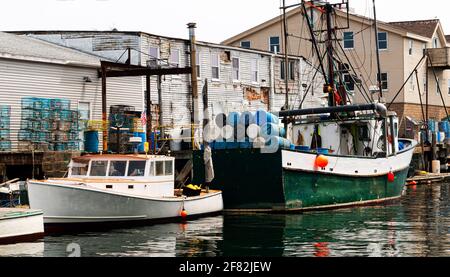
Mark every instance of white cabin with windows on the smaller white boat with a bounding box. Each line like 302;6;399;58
63;155;175;197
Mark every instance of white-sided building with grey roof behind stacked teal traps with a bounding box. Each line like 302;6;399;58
0;33;143;151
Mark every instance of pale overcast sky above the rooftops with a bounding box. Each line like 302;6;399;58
0;0;450;42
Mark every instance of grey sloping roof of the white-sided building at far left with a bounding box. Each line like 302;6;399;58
0;32;102;67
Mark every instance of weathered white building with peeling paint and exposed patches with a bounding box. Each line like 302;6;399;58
15;31;325;129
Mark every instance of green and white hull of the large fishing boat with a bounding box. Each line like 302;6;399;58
194;140;413;209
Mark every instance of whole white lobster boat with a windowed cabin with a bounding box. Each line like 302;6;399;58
28;155;223;224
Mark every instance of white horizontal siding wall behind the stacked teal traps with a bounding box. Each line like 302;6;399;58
0;59;143;150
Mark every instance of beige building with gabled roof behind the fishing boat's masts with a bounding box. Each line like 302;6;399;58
223;5;450;131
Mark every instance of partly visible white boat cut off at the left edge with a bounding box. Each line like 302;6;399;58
0;208;44;244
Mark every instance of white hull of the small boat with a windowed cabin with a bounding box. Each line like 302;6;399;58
28;181;223;224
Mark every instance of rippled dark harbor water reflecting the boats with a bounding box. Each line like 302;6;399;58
0;183;450;257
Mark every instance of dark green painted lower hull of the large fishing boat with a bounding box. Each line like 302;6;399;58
193;149;408;210
